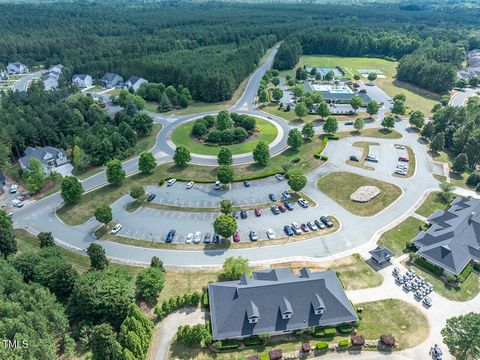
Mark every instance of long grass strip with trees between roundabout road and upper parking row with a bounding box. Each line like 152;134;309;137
57;136;325;225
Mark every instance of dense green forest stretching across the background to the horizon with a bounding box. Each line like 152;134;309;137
0;1;480;102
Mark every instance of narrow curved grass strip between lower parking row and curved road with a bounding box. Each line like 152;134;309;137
101;216;340;251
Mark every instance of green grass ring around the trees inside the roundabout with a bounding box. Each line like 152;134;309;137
172;117;278;156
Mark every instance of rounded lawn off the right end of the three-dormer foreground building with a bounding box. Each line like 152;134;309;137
355;299;429;349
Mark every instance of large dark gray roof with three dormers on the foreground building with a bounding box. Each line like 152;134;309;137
208;268;358;340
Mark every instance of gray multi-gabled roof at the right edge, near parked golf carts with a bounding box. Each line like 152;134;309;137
413;197;480;275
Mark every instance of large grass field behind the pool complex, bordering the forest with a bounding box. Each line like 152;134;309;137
282;55;440;116
